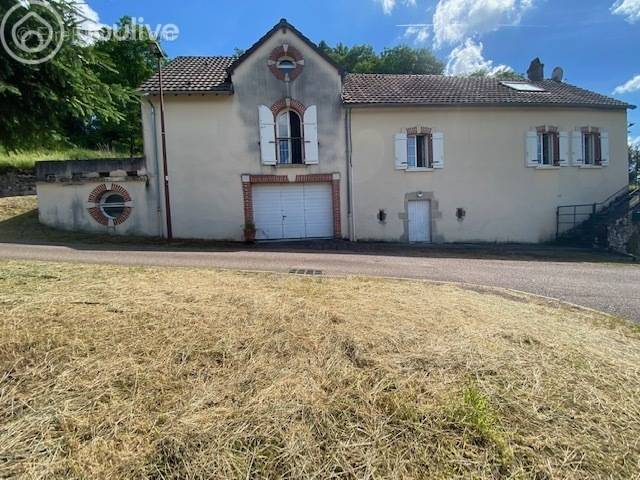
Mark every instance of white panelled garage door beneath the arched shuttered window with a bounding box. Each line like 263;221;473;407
253;183;333;240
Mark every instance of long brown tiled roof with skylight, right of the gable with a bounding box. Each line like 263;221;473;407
343;74;635;109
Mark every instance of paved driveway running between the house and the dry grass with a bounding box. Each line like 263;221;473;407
0;243;640;322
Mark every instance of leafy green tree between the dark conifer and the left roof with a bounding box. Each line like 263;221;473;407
89;17;157;155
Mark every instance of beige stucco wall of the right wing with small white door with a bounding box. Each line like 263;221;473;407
351;107;628;242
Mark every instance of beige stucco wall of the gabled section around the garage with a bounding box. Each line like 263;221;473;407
143;27;348;241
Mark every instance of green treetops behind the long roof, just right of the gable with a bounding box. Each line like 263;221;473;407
319;41;444;74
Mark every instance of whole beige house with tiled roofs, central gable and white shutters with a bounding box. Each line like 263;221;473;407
38;20;633;242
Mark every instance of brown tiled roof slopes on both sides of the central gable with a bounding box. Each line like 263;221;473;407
140;57;635;109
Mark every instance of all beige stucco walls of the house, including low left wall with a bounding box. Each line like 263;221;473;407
33;19;628;243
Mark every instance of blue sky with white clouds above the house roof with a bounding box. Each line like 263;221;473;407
87;0;640;142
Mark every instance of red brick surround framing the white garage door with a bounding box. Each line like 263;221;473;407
242;173;342;239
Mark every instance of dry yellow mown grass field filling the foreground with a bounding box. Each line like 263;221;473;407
0;261;640;479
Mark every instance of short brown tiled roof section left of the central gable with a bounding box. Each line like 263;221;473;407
139;57;236;93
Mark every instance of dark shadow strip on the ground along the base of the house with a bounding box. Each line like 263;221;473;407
0;204;633;264
